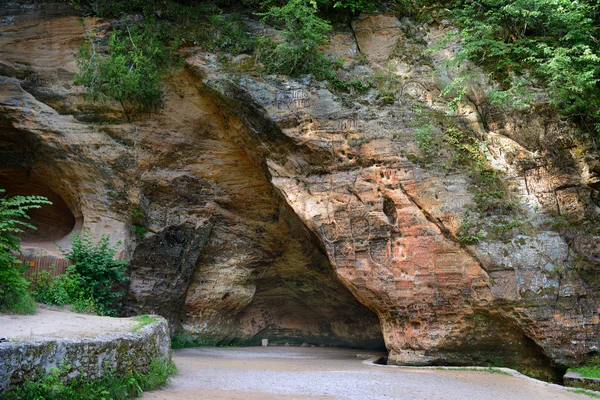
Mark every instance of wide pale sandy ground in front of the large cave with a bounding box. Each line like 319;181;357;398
142;347;588;400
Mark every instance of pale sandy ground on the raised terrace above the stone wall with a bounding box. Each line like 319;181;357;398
0;305;137;341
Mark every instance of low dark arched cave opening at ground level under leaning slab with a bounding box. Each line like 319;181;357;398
231;271;386;351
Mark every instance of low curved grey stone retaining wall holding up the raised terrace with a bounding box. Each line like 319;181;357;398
0;318;171;393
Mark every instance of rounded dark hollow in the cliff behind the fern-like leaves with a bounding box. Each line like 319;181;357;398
0;170;78;255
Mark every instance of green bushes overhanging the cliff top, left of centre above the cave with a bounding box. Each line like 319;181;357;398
63;0;389;101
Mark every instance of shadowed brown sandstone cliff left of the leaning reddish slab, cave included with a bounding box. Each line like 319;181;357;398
0;1;384;348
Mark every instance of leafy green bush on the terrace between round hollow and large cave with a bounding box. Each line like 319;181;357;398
61;232;129;315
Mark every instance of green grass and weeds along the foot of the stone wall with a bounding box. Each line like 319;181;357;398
3;358;177;400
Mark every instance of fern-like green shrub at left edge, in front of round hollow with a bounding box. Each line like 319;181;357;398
0;189;52;314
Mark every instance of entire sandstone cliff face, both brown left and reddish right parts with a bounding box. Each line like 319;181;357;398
0;2;600;374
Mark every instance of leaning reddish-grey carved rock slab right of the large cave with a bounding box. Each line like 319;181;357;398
196;17;598;376
